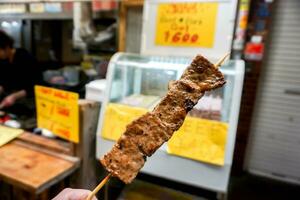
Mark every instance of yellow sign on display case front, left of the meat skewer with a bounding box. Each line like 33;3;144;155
102;103;147;140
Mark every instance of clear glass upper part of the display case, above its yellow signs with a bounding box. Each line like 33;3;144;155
110;55;235;122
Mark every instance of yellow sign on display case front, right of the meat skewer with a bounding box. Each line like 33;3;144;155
168;117;228;166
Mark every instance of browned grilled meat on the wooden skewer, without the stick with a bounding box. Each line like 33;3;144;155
101;56;225;183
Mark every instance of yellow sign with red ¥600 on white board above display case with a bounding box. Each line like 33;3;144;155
155;2;218;48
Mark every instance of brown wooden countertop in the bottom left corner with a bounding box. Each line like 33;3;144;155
0;133;80;194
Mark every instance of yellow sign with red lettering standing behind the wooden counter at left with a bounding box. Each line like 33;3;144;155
35;86;79;143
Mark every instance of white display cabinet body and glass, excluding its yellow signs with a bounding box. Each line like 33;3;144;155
97;53;244;193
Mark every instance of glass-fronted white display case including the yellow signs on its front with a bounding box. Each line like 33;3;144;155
97;53;244;192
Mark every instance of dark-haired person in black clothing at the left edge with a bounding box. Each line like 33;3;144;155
0;30;42;109
